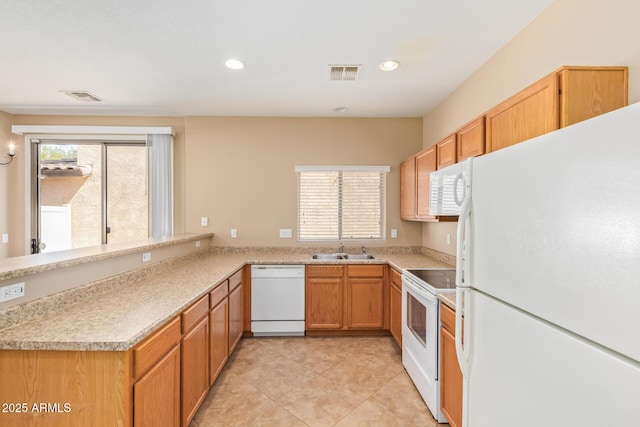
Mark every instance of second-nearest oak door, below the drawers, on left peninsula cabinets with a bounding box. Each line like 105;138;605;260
181;316;209;426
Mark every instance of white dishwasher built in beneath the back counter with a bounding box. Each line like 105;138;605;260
251;265;305;336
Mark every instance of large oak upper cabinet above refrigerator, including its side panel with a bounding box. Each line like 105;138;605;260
486;67;628;152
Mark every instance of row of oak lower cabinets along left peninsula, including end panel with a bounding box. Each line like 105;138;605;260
0;269;243;427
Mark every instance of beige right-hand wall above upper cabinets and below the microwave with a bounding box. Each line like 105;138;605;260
422;0;640;254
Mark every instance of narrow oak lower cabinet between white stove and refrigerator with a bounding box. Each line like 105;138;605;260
440;304;462;427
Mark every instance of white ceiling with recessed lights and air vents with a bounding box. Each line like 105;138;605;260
0;0;552;117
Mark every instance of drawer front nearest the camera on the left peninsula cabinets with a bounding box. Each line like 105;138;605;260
133;317;180;378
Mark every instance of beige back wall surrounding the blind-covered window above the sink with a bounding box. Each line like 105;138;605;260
185;117;422;246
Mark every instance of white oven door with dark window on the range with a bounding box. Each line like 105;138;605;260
402;277;439;381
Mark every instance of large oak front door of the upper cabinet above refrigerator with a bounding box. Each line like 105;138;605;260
486;73;559;153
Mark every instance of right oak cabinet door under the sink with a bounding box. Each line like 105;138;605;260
347;278;384;329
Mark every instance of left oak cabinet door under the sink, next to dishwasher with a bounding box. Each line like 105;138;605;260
305;277;343;329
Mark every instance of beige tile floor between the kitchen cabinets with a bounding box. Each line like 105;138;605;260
190;337;438;427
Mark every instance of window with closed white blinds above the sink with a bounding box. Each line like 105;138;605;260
295;166;389;242
